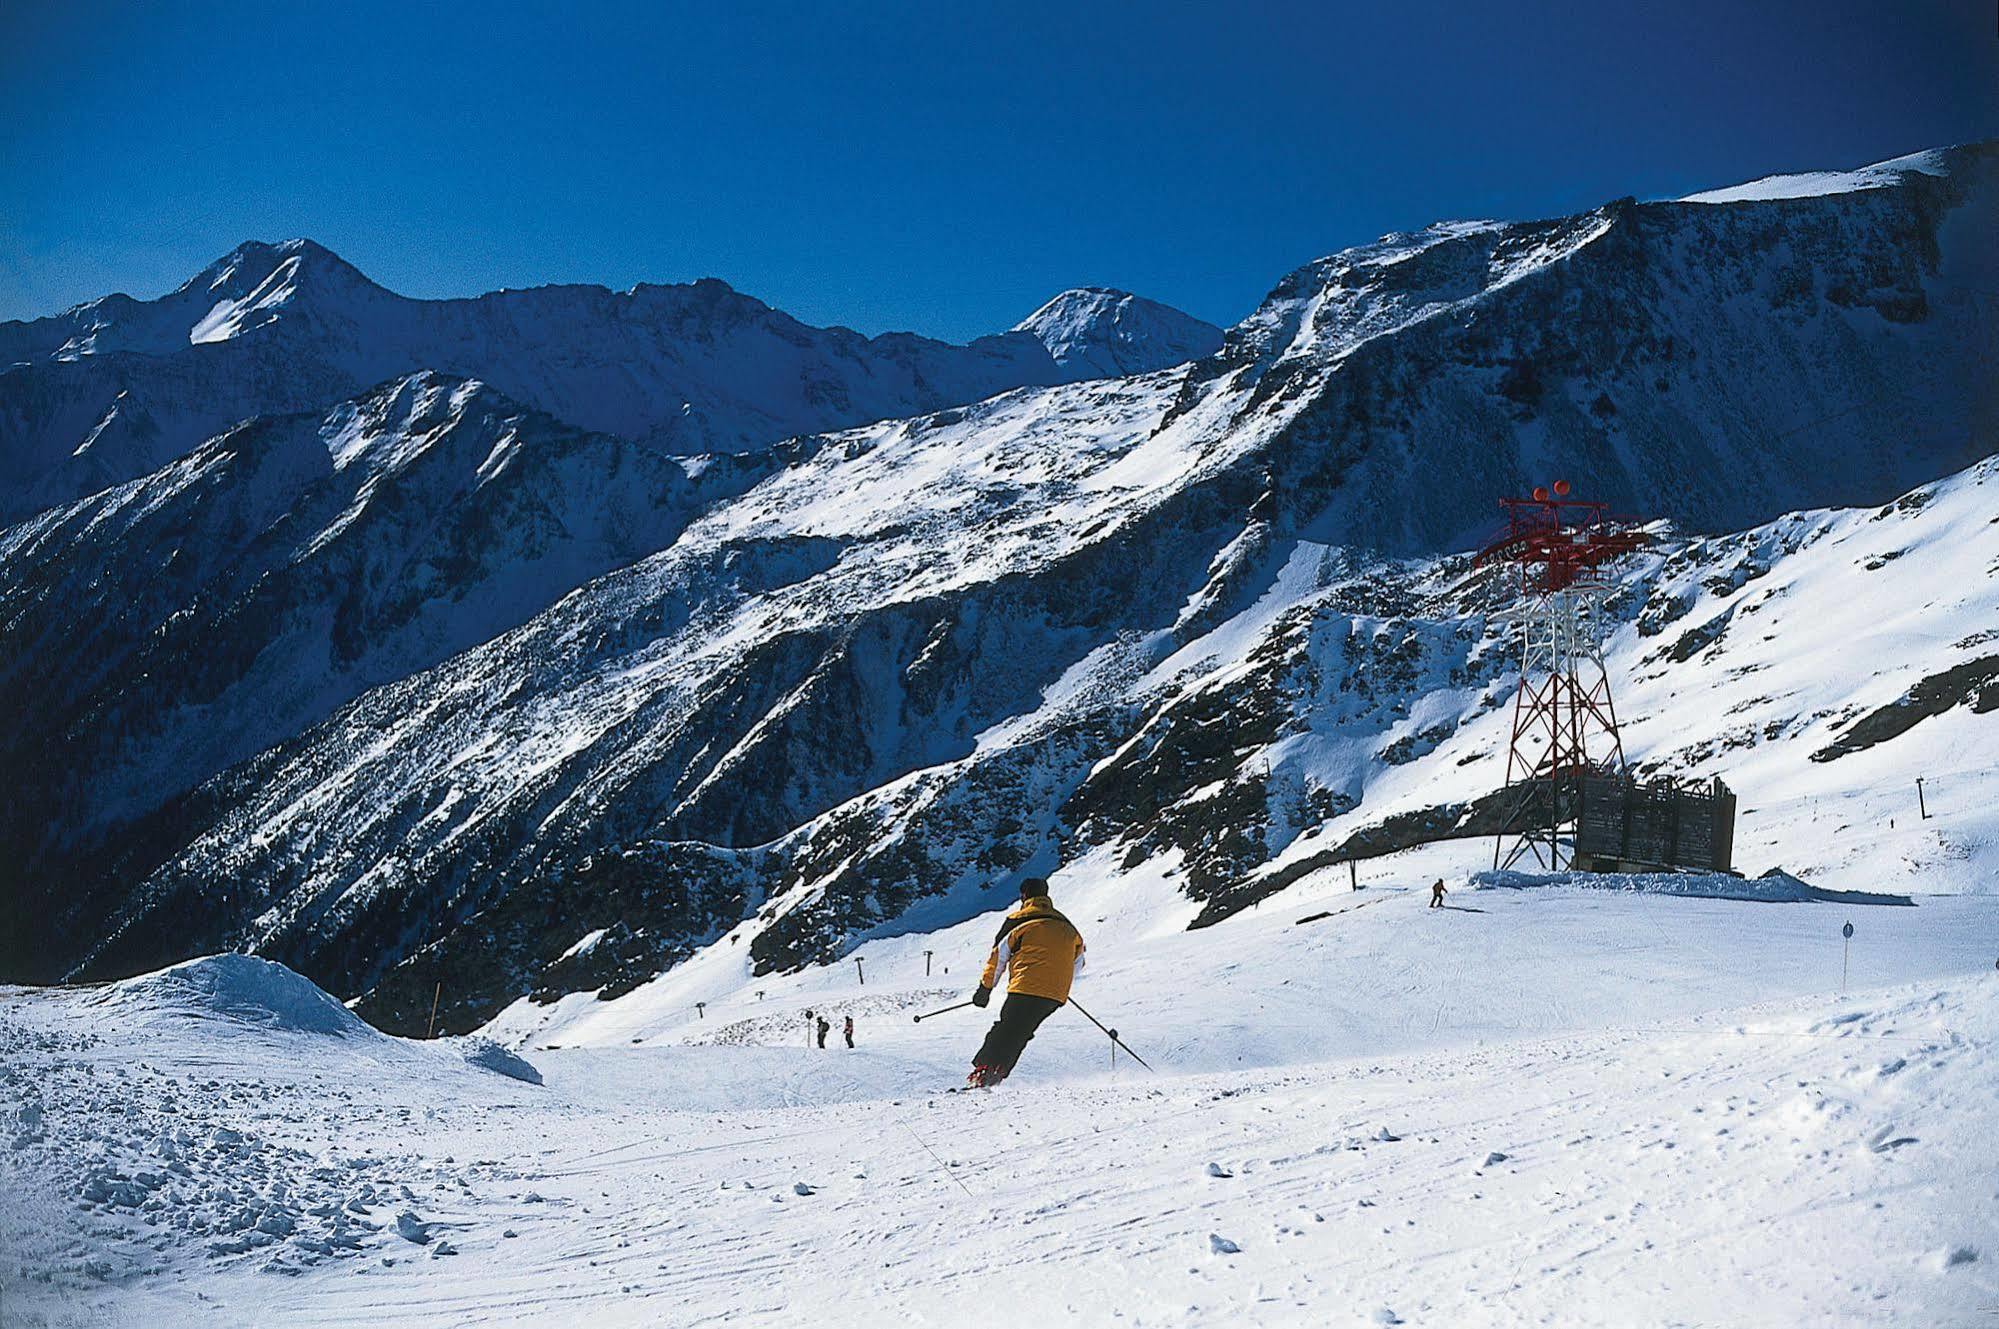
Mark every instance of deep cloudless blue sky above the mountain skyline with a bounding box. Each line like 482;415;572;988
0;0;1999;340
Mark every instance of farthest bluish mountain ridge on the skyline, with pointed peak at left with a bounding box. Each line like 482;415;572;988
0;240;1207;518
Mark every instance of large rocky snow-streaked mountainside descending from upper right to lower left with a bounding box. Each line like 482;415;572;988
6;148;1999;1029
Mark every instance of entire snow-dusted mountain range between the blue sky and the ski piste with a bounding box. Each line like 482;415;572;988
0;144;1999;1029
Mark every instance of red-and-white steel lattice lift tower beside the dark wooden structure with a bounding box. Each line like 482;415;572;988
1477;480;1645;871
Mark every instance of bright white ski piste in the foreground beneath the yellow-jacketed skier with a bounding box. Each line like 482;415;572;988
0;843;1999;1329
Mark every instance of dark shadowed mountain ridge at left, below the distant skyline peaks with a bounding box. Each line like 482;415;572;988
0;374;790;969
